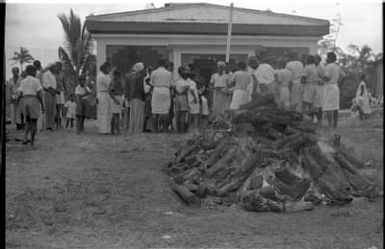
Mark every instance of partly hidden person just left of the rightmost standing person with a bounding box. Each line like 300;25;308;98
314;55;325;125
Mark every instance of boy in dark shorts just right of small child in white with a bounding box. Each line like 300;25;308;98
75;76;91;134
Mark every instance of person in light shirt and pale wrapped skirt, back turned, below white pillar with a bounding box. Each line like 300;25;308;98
150;60;172;132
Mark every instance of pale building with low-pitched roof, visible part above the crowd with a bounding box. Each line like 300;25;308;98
86;3;329;79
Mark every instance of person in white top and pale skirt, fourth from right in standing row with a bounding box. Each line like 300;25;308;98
286;53;303;112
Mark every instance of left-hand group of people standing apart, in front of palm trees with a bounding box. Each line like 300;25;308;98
5;60;95;145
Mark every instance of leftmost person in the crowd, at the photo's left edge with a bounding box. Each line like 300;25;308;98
6;67;23;130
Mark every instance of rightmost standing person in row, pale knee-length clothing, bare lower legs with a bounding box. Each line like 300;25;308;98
322;52;340;128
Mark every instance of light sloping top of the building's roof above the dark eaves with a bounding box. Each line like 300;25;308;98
87;3;329;26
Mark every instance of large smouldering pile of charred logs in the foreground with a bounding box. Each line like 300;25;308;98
168;96;378;212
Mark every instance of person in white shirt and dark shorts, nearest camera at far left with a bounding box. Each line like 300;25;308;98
19;65;44;145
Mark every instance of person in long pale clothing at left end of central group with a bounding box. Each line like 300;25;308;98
96;62;111;135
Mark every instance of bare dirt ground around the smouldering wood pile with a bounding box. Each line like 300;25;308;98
6;115;383;249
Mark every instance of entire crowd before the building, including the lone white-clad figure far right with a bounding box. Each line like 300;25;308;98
7;49;376;144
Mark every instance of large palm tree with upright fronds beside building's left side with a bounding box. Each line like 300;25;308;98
57;9;92;92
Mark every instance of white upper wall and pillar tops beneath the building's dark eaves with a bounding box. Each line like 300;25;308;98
93;34;322;75
